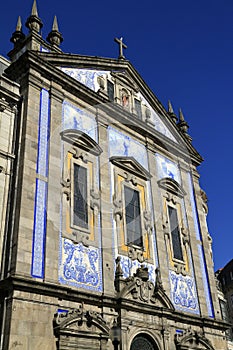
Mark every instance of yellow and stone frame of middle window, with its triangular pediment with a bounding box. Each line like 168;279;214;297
110;156;154;262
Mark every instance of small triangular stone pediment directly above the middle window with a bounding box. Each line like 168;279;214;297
110;157;151;180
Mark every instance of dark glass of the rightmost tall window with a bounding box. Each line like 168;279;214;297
168;206;183;260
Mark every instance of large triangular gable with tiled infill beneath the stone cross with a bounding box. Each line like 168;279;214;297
34;52;202;165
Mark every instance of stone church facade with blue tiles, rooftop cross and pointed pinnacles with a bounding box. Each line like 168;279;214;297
0;1;227;350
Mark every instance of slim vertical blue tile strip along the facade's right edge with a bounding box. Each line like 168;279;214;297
187;172;214;317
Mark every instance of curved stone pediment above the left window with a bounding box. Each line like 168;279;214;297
61;129;102;156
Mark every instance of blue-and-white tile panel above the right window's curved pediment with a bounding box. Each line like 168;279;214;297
156;153;181;184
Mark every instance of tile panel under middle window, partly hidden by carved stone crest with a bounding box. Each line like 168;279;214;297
119;255;155;283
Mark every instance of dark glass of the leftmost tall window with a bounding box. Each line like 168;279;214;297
73;164;88;228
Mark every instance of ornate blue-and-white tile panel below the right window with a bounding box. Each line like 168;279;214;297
169;271;200;314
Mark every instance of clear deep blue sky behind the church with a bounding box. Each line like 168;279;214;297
0;0;233;269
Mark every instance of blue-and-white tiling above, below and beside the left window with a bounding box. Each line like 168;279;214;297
59;102;103;292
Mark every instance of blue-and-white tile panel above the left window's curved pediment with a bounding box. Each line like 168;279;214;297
62;102;97;142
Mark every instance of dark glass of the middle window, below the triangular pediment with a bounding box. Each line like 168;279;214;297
125;186;143;247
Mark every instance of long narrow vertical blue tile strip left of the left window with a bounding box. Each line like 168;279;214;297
31;89;50;278
